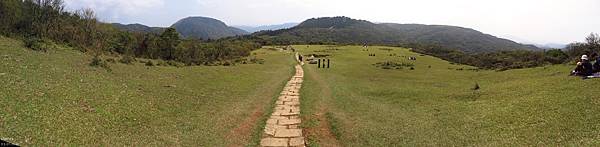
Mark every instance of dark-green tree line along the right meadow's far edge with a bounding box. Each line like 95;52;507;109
406;33;600;70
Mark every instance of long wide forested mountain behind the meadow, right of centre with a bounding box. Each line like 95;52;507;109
253;17;538;52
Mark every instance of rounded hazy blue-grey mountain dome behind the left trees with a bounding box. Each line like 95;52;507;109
171;17;249;39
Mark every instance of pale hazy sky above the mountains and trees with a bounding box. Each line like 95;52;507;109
65;0;600;44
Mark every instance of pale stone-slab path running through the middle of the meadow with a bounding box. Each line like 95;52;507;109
260;65;305;147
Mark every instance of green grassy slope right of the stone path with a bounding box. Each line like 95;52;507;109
295;46;600;146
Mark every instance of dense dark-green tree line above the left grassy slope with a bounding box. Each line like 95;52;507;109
0;0;261;65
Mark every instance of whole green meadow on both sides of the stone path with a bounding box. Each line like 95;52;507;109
0;37;600;146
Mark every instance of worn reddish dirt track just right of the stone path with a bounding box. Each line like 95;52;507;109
305;64;341;147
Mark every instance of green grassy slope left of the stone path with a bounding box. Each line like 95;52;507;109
0;37;294;146
